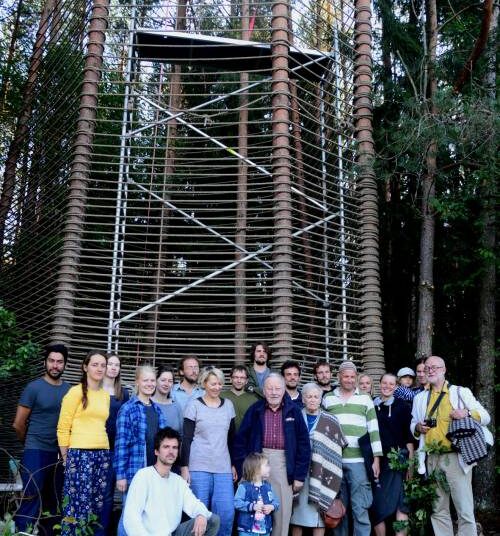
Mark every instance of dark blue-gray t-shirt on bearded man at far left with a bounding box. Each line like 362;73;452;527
19;378;71;452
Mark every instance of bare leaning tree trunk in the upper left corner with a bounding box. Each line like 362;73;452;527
0;0;55;269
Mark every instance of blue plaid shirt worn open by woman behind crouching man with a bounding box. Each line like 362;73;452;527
114;397;168;484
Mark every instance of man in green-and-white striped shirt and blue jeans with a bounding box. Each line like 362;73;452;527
323;361;382;536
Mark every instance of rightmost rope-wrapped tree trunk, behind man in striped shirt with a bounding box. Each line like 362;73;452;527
354;0;385;378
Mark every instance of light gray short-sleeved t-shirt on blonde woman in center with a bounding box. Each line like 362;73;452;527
184;399;236;473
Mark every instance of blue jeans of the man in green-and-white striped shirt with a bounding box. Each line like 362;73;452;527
333;463;373;536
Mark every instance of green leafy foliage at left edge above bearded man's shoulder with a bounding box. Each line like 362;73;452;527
0;303;40;380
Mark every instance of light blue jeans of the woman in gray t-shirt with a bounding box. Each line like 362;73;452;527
191;471;234;536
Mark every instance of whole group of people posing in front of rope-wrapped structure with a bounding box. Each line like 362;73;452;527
13;342;489;536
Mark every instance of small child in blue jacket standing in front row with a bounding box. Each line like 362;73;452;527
234;452;279;536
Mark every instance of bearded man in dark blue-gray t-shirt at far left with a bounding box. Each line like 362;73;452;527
12;344;70;534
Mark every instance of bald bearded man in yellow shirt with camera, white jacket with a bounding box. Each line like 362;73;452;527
411;356;493;536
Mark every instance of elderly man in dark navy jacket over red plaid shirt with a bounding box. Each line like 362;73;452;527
234;372;311;536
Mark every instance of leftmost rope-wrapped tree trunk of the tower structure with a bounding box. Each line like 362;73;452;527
51;0;109;345
